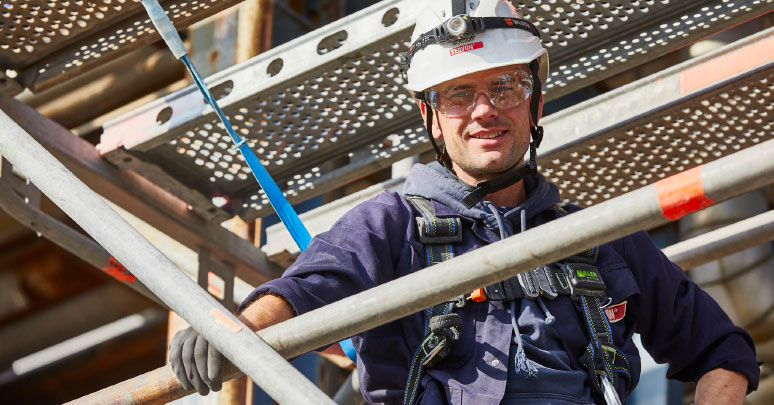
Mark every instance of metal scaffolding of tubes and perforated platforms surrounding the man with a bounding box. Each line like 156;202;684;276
0;0;774;403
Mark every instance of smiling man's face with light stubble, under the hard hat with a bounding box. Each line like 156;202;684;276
423;66;531;185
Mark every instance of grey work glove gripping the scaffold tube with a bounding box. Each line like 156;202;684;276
169;328;226;395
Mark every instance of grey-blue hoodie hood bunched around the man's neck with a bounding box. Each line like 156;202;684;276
403;162;559;235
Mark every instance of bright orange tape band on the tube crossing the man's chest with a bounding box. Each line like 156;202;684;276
656;166;715;221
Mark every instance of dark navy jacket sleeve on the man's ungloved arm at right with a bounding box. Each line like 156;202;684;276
619;232;760;390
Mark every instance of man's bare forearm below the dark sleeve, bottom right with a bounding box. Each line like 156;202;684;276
696;368;747;405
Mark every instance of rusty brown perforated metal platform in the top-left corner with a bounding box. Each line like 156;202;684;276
0;0;241;90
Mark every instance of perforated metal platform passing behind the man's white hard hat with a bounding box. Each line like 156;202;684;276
99;0;774;219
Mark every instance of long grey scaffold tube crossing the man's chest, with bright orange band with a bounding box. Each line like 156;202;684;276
77;140;774;404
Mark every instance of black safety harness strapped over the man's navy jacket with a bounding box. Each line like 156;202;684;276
403;195;631;405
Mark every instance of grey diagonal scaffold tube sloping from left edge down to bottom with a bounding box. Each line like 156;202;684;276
0;112;332;403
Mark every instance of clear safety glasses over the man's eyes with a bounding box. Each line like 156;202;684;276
426;70;532;117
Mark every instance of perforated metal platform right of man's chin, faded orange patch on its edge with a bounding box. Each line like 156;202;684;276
539;34;774;206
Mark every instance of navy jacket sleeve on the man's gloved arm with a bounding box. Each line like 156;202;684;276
239;191;412;315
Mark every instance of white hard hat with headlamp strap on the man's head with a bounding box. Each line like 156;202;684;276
406;0;548;92
